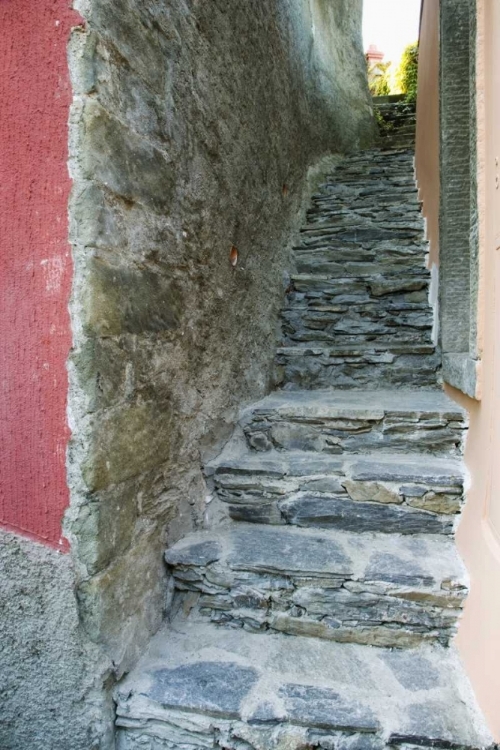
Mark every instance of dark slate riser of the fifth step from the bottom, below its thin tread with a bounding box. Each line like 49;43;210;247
277;354;440;389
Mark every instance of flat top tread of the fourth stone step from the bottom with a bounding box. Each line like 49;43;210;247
246;389;466;420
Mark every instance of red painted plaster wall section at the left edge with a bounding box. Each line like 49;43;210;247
0;0;78;549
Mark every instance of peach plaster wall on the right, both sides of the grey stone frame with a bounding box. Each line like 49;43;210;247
416;0;500;741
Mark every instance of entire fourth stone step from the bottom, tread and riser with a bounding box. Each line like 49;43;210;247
240;389;466;456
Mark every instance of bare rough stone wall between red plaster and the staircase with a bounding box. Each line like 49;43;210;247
65;0;373;675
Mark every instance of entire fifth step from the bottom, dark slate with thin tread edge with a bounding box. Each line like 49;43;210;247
276;346;441;389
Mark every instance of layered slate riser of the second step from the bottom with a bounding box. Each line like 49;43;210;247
168;564;465;648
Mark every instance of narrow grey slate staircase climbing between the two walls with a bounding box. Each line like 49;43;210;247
115;144;493;750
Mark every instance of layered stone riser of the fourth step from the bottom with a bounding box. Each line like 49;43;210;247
244;414;464;455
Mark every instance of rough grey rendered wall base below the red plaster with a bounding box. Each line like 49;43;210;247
0;531;113;750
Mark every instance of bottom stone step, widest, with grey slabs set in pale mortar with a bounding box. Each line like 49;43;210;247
114;618;492;750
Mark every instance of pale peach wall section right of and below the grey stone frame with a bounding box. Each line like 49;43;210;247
456;0;500;741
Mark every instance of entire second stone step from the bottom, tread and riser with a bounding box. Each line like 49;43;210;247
165;523;467;648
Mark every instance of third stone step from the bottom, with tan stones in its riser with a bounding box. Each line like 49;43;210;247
205;450;463;534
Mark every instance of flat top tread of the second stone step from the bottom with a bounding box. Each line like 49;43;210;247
165;523;468;594
